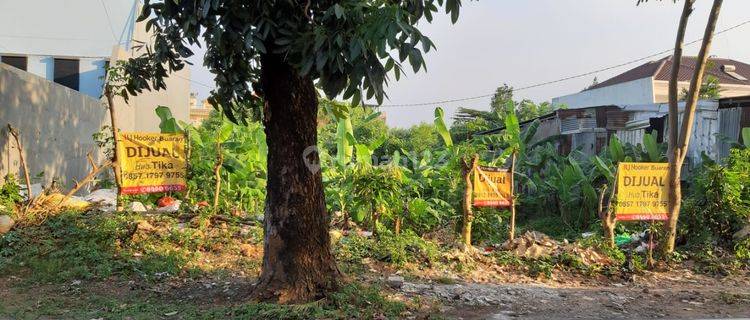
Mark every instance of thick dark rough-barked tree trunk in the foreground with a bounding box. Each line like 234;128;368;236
253;55;340;303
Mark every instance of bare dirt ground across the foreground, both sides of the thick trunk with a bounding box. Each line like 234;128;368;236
0;214;750;320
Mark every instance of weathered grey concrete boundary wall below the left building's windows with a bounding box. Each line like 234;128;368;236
0;63;109;186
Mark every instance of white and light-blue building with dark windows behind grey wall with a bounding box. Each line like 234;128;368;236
0;0;190;127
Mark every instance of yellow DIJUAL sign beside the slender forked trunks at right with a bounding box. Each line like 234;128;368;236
615;162;669;221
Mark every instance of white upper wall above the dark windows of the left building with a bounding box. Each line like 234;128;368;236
0;0;140;58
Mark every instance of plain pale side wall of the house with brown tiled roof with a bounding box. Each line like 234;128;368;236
552;77;654;109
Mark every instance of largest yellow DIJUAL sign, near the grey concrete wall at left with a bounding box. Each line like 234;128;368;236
118;132;187;194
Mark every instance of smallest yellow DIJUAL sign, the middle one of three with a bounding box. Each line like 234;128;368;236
473;166;513;207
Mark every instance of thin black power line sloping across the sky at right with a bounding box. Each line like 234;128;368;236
379;20;750;108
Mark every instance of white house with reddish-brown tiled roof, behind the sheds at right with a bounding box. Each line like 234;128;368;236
552;56;750;109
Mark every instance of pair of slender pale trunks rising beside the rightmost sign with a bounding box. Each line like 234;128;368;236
664;0;723;253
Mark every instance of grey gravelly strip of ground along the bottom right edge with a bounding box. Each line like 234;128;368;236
429;284;750;319
